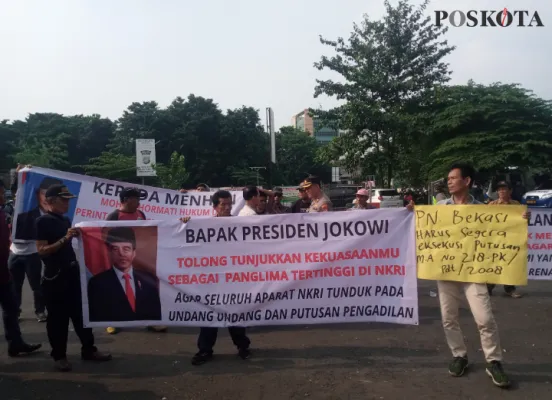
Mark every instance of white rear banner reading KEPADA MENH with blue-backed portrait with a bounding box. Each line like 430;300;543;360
13;167;244;241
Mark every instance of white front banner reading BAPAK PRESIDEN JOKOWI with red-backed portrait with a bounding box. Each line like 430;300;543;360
77;209;418;327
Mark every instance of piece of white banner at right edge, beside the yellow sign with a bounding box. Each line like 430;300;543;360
527;208;552;280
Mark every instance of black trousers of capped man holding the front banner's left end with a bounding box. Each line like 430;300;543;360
42;266;97;361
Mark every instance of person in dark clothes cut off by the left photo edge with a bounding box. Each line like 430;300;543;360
0;181;42;357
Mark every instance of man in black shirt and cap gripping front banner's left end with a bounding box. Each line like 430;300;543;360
36;185;111;371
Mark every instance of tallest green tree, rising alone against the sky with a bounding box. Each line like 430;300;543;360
315;0;454;188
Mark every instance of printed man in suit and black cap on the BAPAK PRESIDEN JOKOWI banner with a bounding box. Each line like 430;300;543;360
88;227;161;322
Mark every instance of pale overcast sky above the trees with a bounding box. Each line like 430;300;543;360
0;0;552;127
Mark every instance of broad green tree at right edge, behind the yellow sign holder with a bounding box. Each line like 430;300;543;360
424;81;552;179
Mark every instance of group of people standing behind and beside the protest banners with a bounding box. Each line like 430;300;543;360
0;163;530;387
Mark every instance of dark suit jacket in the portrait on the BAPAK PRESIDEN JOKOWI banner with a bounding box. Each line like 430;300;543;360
88;268;161;322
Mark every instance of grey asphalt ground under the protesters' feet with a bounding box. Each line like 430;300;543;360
0;281;552;400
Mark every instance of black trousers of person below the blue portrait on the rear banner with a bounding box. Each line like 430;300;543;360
8;253;45;314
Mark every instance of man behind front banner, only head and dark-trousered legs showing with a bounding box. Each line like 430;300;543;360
192;190;251;365
